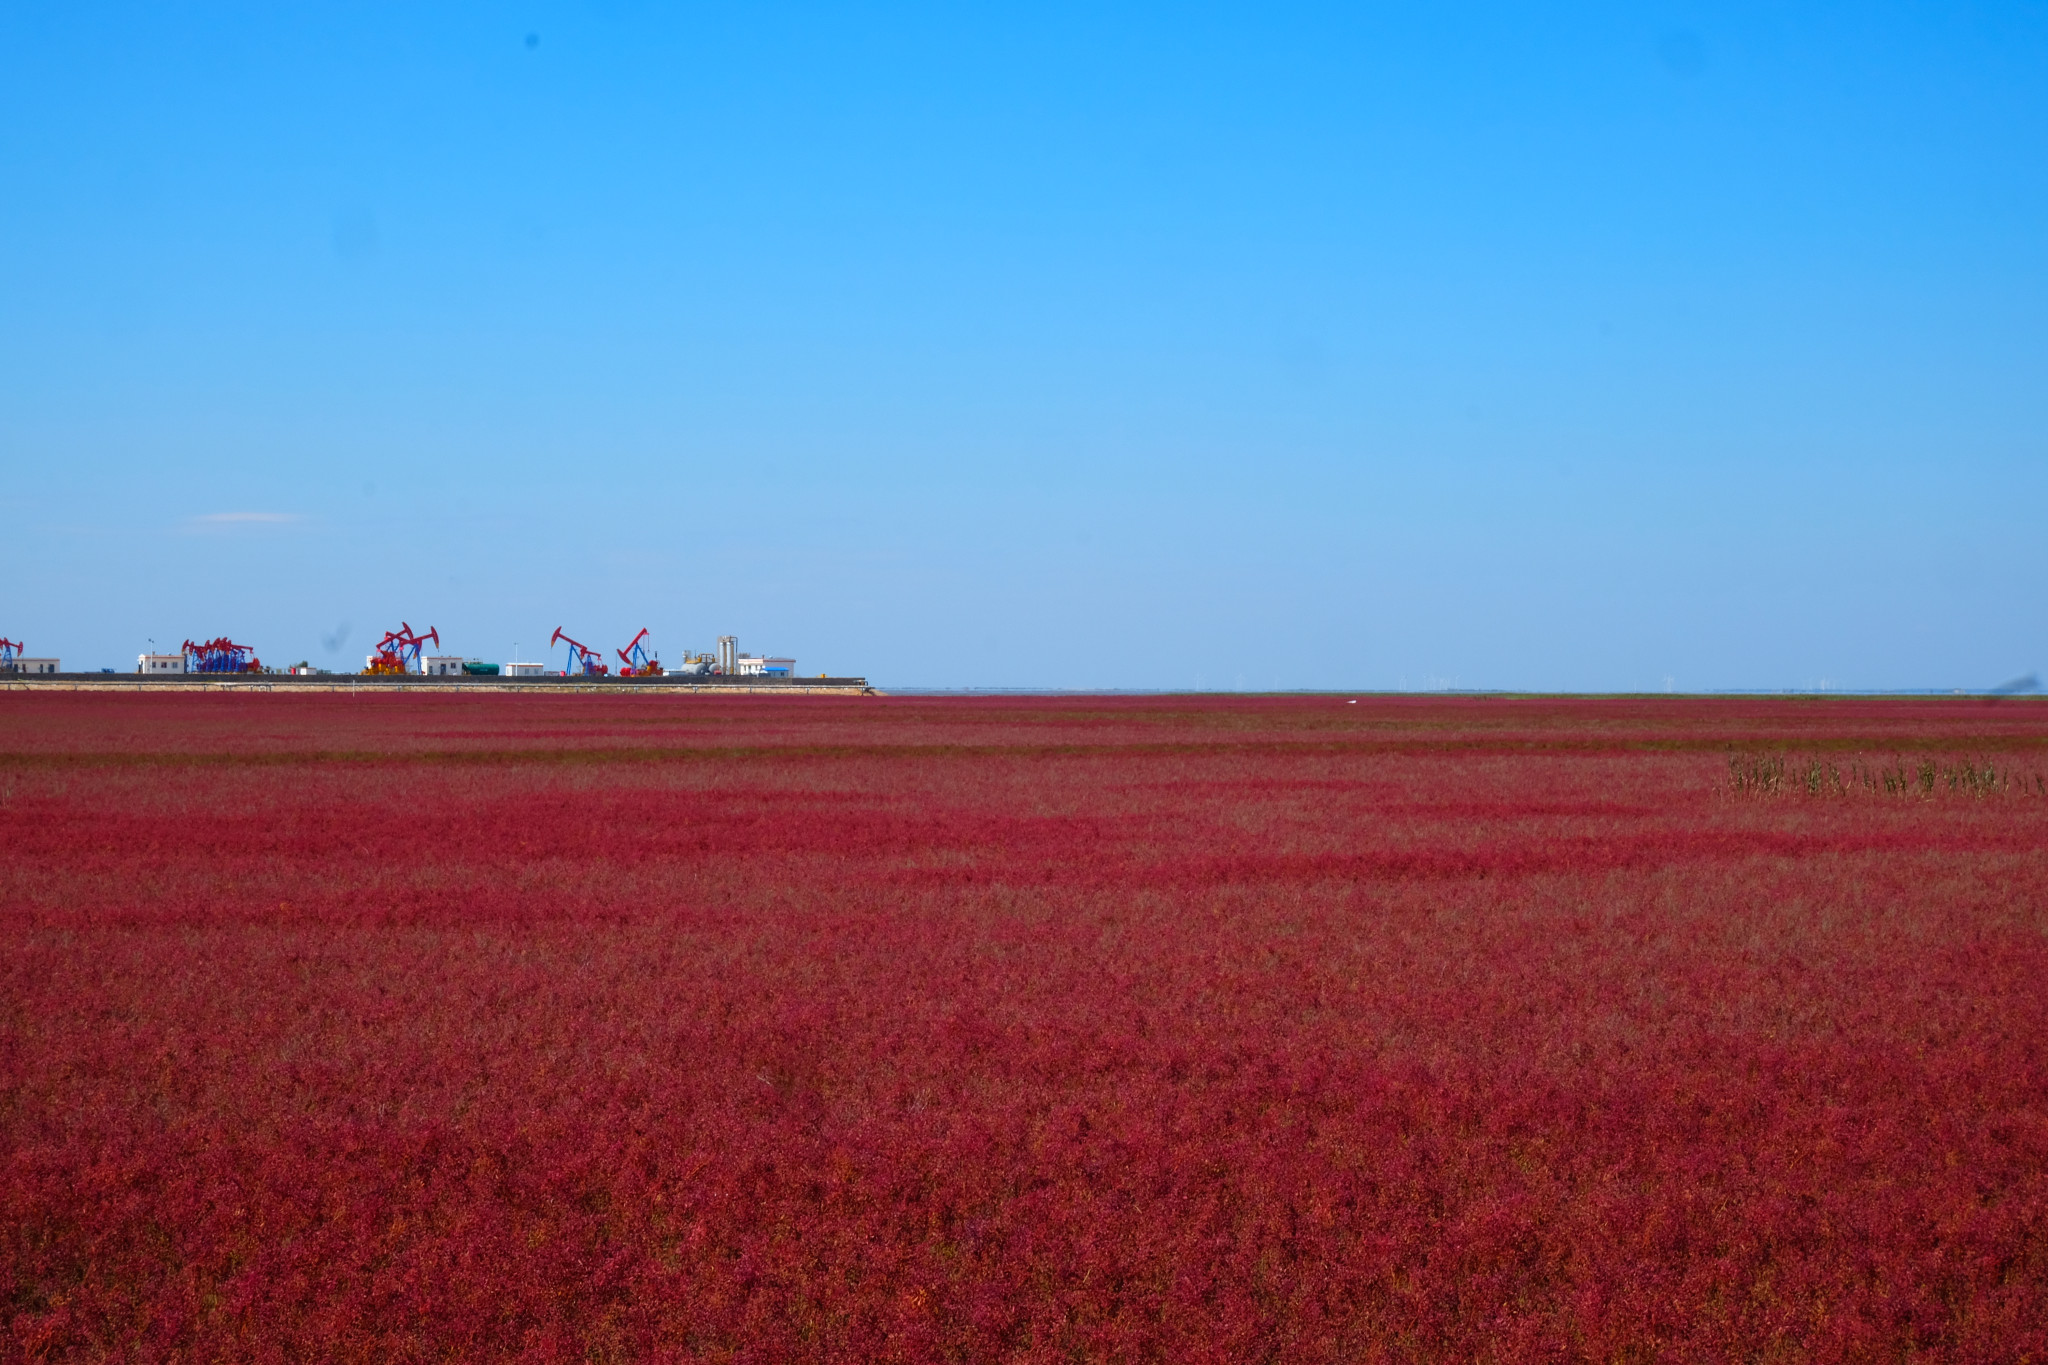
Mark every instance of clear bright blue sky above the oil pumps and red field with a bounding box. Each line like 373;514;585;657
0;0;2048;690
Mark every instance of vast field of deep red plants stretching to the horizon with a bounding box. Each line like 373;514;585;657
0;692;2048;1361
